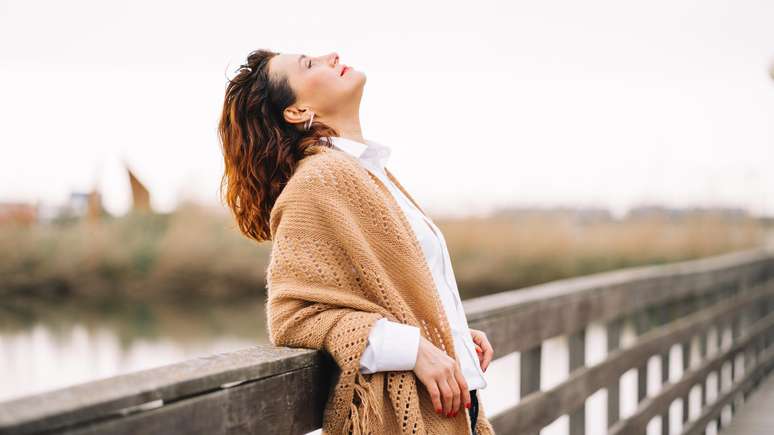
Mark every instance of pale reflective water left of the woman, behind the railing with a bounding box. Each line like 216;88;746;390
0;302;268;402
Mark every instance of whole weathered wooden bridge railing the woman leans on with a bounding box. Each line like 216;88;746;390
0;250;774;435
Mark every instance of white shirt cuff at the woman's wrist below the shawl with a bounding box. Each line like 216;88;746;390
360;317;419;374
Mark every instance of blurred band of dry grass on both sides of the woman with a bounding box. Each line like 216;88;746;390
0;204;764;300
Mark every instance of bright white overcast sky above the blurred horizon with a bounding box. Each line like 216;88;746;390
0;0;774;218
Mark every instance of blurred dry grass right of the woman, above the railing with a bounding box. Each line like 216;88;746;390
438;213;764;297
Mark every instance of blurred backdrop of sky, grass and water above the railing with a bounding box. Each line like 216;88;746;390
0;0;774;432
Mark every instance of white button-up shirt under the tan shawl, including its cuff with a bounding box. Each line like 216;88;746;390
331;137;487;390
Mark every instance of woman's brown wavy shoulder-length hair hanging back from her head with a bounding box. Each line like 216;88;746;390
218;49;338;242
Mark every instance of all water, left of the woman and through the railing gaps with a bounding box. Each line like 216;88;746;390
0;301;743;435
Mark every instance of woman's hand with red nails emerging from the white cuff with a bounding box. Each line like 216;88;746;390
414;336;470;417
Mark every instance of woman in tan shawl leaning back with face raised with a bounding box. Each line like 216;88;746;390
218;50;494;435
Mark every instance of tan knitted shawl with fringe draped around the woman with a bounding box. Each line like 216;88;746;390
266;146;494;435
